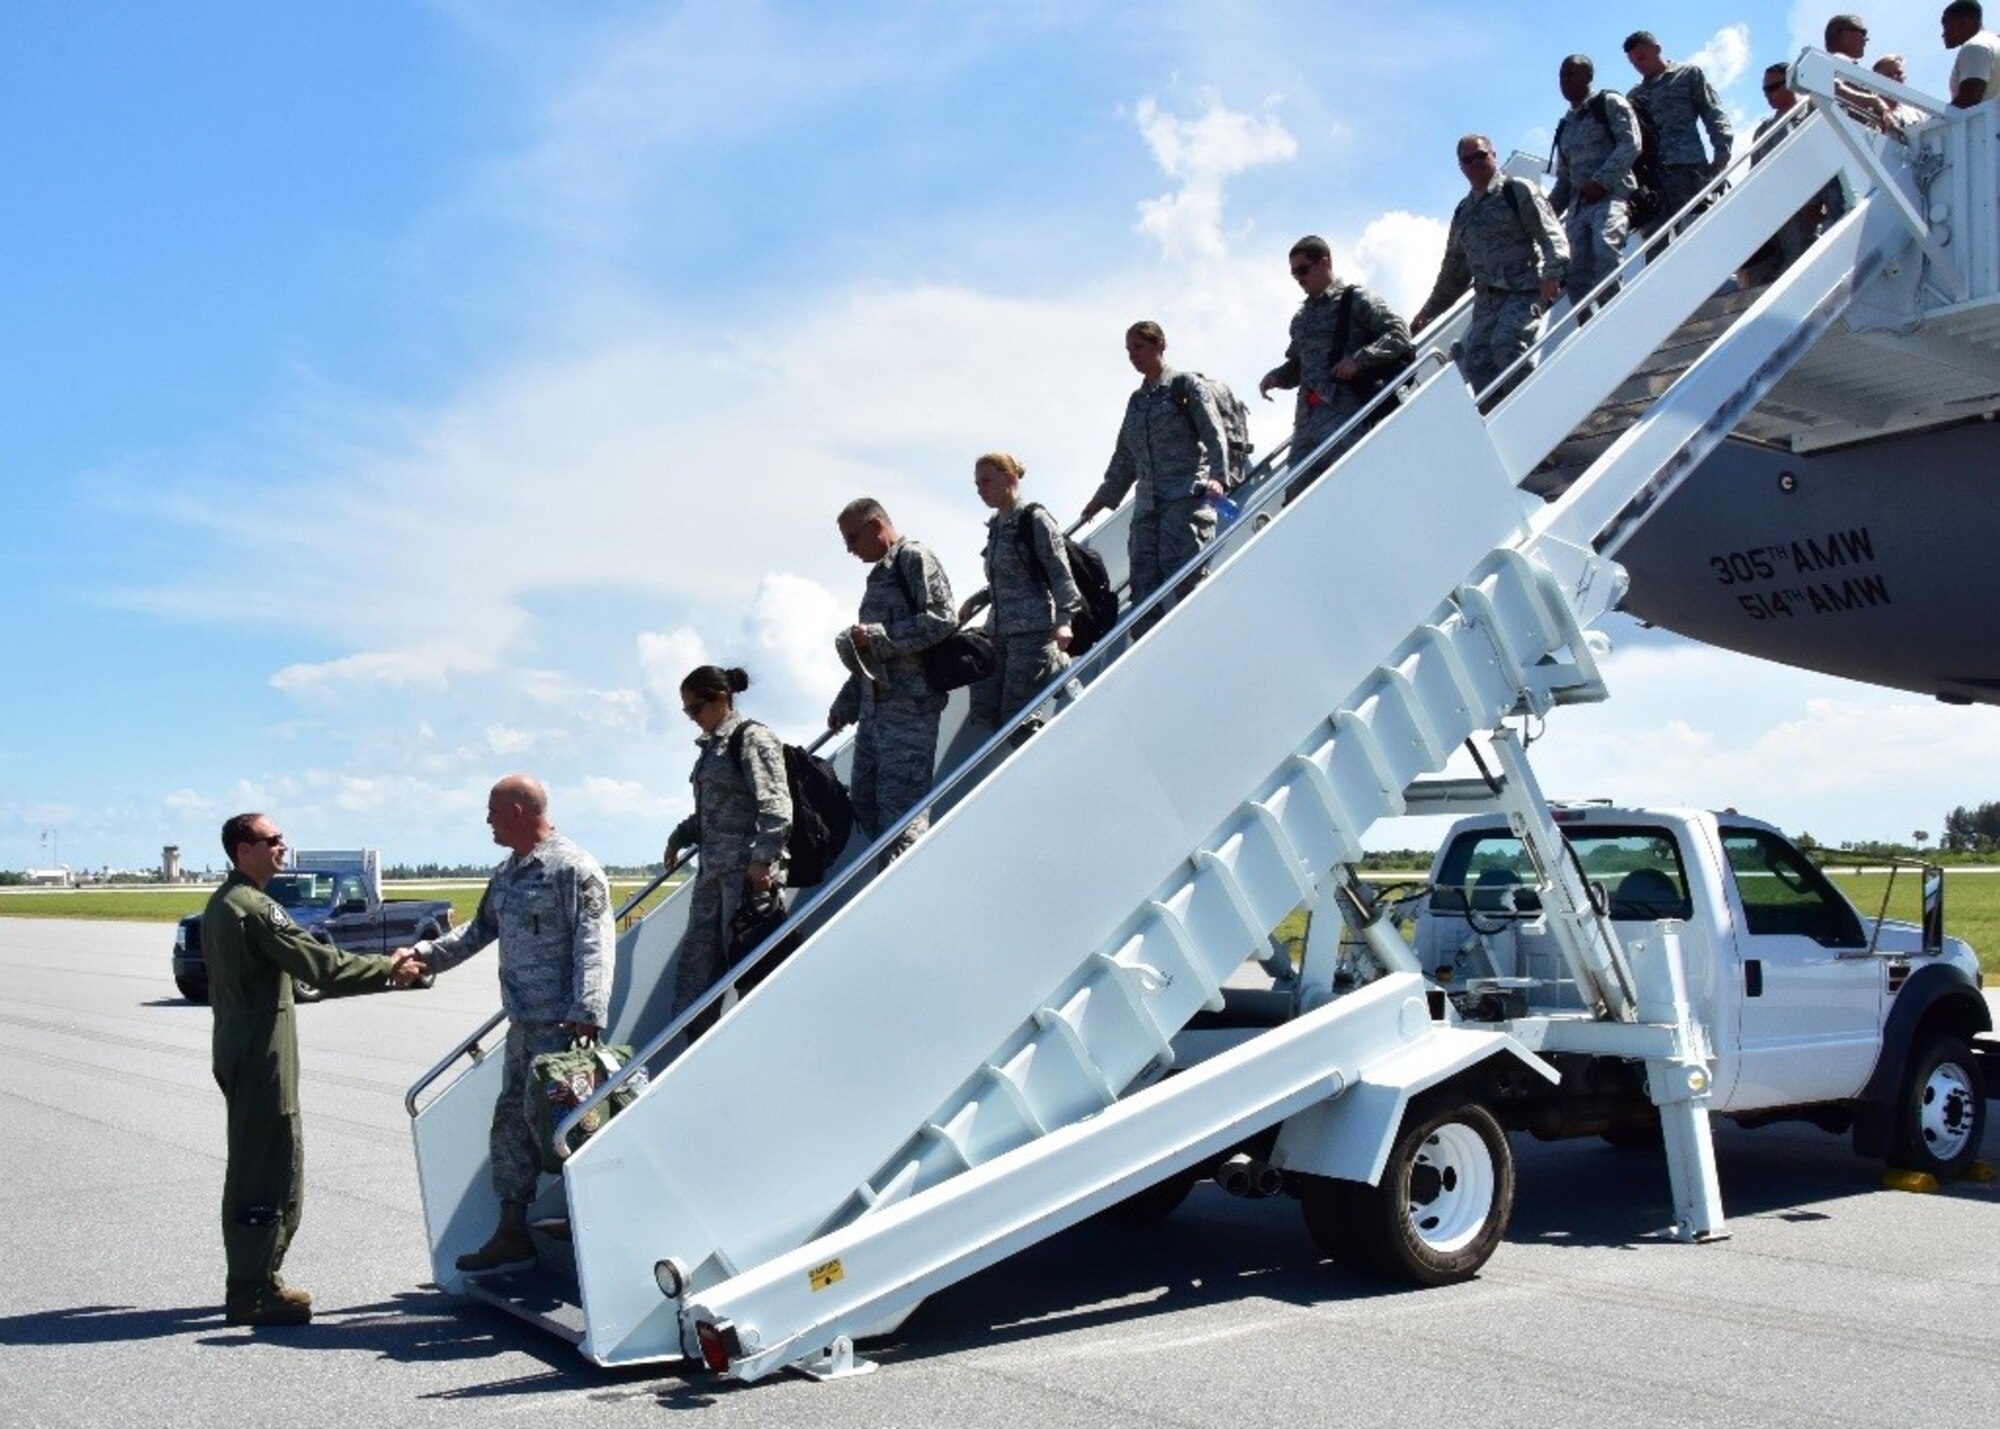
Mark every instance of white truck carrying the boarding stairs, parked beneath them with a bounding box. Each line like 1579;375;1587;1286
1126;781;1992;1285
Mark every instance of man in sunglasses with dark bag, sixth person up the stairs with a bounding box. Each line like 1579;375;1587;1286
1258;234;1414;484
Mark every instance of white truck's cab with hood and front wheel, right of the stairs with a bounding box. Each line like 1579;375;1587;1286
1416;805;1990;1173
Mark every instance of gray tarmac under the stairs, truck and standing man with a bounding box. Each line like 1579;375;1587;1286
0;919;2000;1429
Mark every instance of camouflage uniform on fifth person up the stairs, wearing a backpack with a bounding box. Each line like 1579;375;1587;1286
1094;368;1230;604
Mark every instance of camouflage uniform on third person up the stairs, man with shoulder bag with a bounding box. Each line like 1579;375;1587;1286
834;538;958;859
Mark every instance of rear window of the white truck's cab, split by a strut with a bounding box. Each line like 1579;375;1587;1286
1430;825;1694;921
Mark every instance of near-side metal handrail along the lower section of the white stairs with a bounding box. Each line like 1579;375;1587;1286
552;336;1460;1161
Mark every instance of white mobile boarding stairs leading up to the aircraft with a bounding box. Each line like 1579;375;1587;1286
410;54;1990;1379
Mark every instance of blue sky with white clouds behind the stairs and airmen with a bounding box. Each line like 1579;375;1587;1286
0;0;2000;869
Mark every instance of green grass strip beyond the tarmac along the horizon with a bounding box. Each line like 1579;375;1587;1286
0;869;2000;977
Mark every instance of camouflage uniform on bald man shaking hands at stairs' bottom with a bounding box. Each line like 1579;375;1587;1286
416;833;618;1203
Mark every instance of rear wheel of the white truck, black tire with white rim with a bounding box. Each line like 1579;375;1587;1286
1300;1101;1514;1285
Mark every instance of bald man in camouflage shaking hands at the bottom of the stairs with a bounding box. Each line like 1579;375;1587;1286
414;775;618;1271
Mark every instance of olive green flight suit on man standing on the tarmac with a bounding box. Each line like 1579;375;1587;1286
202;873;402;1305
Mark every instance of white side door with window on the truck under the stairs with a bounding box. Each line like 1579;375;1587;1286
1720;829;1886;1111
